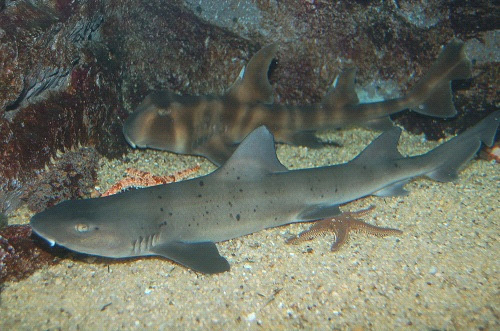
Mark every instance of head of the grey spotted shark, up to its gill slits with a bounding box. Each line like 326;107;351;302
30;198;137;257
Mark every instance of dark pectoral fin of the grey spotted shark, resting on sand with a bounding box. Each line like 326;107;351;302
151;241;229;274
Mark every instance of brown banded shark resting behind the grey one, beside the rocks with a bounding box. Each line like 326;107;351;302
123;39;471;165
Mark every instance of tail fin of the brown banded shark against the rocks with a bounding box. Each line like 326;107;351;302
403;39;472;117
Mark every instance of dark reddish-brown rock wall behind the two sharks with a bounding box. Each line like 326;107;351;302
0;0;500;213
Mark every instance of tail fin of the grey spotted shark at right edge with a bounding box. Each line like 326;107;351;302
425;111;500;182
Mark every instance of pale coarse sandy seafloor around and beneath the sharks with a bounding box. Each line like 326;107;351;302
0;129;500;330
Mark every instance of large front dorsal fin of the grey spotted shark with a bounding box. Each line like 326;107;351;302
217;126;288;180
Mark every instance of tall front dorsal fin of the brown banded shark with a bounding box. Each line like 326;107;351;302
227;43;278;103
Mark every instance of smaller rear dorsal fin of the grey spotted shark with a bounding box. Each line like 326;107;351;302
351;127;403;165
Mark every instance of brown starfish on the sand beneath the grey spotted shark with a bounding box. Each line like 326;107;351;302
286;206;403;252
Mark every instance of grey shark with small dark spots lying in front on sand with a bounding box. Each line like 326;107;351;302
30;111;500;274
